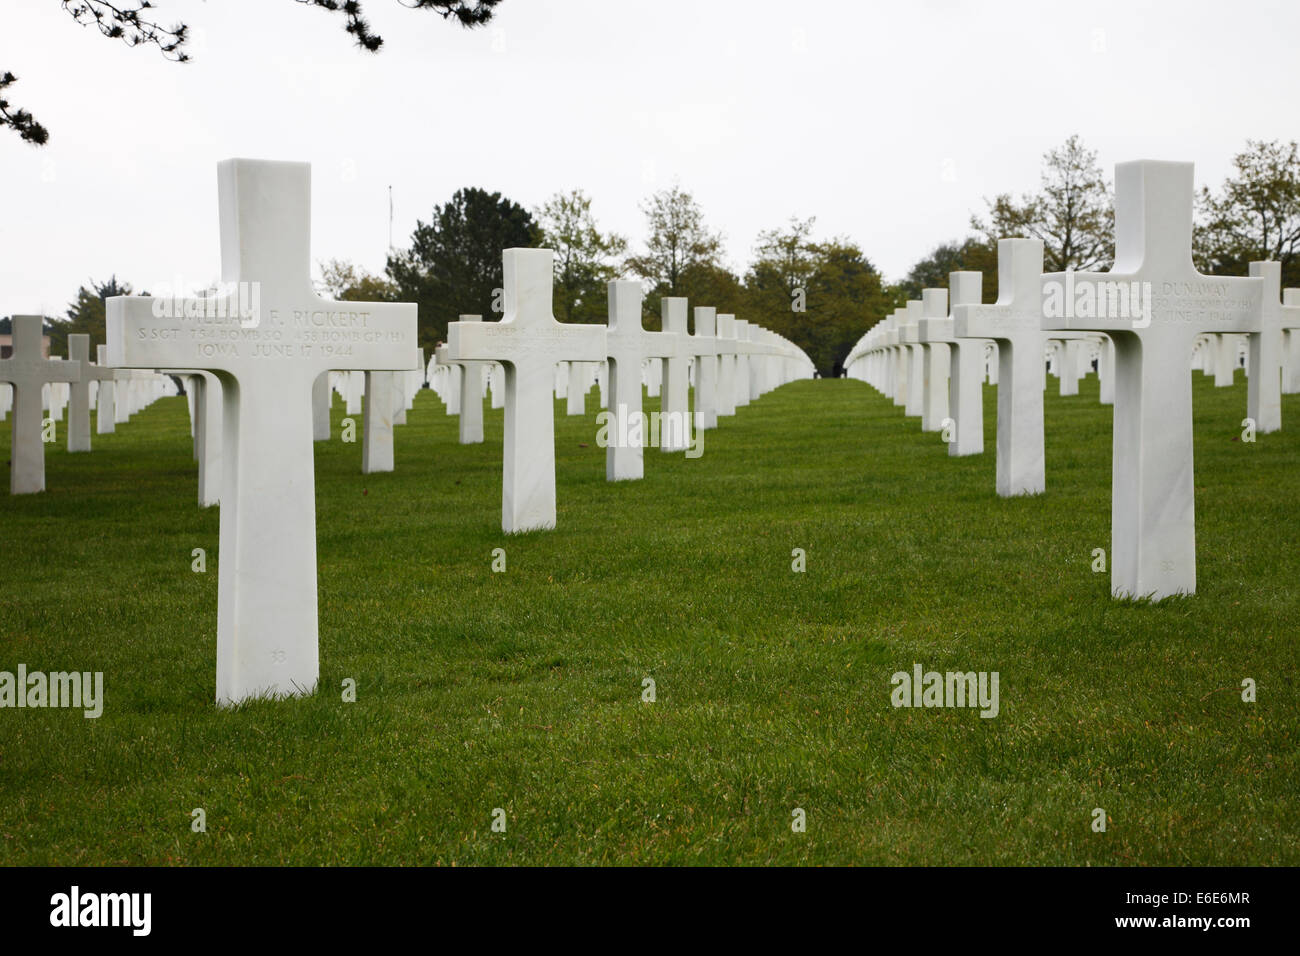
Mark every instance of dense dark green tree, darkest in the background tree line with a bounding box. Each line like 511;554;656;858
386;187;541;349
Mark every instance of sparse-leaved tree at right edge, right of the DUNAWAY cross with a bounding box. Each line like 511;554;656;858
1193;139;1300;287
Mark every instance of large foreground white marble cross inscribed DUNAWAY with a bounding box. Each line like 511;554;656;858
1043;160;1264;600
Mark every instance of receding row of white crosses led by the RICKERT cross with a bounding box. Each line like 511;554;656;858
91;160;811;704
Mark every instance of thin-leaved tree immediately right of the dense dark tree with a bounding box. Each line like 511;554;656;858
536;189;628;323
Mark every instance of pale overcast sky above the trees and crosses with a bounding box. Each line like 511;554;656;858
0;0;1300;315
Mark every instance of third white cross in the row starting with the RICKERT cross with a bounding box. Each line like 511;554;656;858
605;280;680;481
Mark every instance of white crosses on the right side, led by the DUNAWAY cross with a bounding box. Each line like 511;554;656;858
846;160;1300;600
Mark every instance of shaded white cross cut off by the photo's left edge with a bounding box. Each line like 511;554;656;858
0;315;81;494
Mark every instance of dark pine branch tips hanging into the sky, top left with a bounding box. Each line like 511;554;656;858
0;0;501;146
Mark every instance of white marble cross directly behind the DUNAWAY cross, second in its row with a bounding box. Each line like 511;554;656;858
953;239;1047;498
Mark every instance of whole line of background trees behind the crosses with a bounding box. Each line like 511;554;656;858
17;137;1300;375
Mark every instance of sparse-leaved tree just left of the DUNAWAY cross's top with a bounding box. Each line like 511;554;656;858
971;135;1115;272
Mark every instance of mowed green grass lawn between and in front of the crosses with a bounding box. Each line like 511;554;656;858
0;373;1300;865
